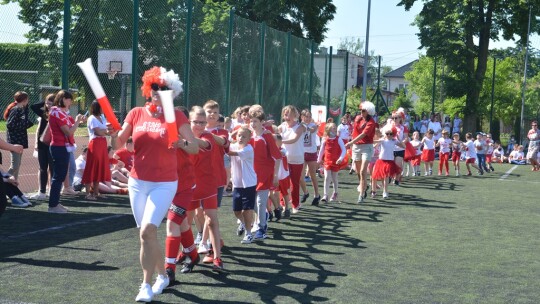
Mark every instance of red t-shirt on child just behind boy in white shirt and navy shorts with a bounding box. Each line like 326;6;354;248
249;132;281;191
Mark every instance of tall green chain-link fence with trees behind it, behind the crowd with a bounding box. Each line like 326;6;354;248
0;0;350;190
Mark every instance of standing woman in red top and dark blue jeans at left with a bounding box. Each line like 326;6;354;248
49;90;85;213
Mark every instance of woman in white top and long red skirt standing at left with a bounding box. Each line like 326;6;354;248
82;100;111;200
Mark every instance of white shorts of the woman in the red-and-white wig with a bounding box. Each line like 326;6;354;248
128;177;178;228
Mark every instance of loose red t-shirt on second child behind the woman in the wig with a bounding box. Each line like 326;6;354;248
189;132;215;200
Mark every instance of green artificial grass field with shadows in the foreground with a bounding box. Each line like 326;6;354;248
0;165;540;303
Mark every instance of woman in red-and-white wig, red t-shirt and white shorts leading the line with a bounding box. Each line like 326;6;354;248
111;67;198;302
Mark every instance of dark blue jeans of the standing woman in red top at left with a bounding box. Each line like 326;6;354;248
49;146;70;208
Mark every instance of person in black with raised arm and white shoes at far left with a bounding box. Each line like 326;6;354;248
30;94;54;201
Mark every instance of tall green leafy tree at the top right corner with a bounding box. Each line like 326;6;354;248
398;0;540;135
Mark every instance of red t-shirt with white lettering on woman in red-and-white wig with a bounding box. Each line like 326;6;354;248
125;107;189;182
